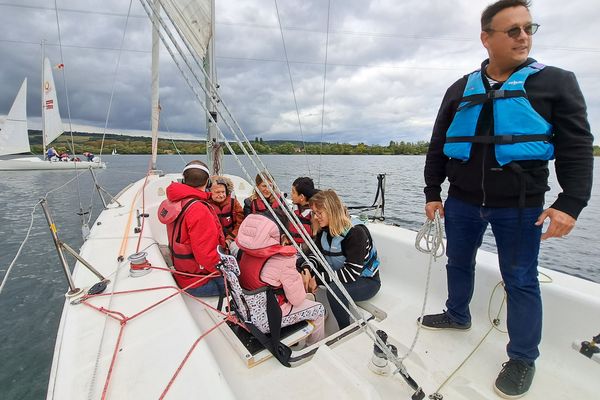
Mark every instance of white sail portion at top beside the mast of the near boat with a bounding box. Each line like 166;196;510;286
161;0;212;57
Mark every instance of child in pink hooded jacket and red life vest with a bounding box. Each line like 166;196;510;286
235;214;325;345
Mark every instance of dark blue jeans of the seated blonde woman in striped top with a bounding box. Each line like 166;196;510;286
327;273;381;329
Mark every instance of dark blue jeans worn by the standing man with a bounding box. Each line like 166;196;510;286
444;197;542;362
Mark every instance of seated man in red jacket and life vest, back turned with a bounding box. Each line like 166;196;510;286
158;160;225;297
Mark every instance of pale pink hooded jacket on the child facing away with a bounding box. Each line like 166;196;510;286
236;214;306;315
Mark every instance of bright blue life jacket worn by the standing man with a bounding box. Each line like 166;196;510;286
444;63;554;166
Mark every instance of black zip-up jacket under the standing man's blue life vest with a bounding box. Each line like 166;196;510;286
424;58;594;218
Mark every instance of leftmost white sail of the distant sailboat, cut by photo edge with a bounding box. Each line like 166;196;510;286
0;78;30;155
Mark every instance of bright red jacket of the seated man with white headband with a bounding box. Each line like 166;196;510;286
162;182;225;288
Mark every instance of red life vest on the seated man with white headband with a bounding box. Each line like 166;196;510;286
158;198;214;288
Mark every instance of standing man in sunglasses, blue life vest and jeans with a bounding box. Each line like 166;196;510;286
421;0;593;398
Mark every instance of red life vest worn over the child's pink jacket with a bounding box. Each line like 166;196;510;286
239;245;296;305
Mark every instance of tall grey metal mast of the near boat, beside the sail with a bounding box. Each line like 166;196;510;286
204;0;223;175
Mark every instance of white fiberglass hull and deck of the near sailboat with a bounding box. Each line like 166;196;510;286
47;175;600;399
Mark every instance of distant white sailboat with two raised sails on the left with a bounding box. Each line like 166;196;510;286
0;57;106;170
